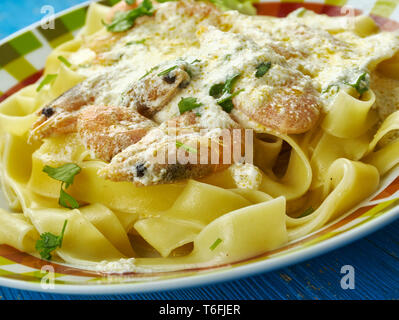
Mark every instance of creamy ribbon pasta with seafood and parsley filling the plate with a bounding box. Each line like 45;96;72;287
0;0;399;272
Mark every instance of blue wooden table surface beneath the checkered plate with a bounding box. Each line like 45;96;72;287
0;0;399;300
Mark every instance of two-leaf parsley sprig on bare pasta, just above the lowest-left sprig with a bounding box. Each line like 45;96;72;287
43;163;82;209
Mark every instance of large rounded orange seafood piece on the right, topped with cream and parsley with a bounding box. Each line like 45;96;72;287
197;27;321;134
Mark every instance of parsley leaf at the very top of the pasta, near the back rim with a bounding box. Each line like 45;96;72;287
105;0;154;32
